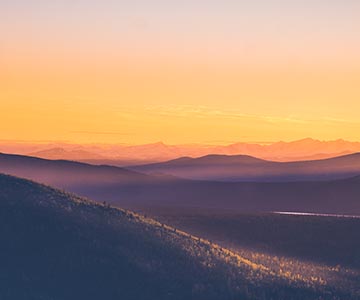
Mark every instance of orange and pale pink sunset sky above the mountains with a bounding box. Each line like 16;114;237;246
0;0;360;144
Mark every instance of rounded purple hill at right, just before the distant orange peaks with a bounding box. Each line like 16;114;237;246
130;153;360;182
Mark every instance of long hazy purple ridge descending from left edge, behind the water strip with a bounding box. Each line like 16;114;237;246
0;154;360;214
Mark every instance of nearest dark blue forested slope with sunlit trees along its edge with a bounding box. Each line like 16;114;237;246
0;175;357;299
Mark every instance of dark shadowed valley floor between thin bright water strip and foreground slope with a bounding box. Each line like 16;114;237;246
157;210;360;270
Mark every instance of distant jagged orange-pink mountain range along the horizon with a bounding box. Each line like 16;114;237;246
0;138;360;166
